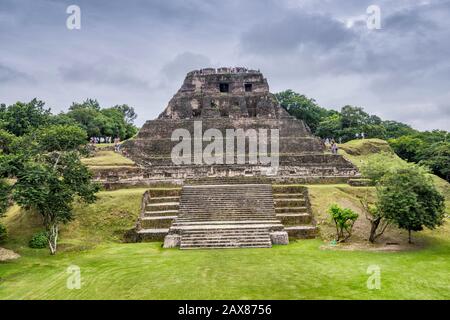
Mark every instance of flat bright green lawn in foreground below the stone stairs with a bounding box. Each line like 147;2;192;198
0;239;450;299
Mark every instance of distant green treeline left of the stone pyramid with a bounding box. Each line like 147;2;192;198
0;99;137;140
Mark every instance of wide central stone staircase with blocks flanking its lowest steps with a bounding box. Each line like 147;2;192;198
164;184;288;249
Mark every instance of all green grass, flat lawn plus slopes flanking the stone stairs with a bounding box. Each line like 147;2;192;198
0;141;450;299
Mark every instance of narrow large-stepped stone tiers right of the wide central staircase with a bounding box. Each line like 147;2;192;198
273;185;317;239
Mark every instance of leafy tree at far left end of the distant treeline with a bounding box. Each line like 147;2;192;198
1;99;51;136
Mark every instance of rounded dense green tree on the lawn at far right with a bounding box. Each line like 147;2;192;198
377;166;445;243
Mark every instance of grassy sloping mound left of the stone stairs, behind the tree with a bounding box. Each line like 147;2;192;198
2;188;145;253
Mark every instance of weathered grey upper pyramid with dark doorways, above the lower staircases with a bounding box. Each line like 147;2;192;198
124;68;357;180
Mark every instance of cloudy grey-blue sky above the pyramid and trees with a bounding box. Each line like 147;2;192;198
0;0;450;130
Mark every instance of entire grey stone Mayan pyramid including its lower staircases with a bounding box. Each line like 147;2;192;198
124;68;357;249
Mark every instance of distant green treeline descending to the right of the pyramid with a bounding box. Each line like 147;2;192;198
275;90;450;181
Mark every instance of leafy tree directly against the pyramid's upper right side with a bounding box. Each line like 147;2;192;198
275;90;335;132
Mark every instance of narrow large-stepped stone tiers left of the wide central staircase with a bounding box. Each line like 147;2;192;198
136;188;181;242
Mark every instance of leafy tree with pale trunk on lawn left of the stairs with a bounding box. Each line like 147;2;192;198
13;152;99;255
